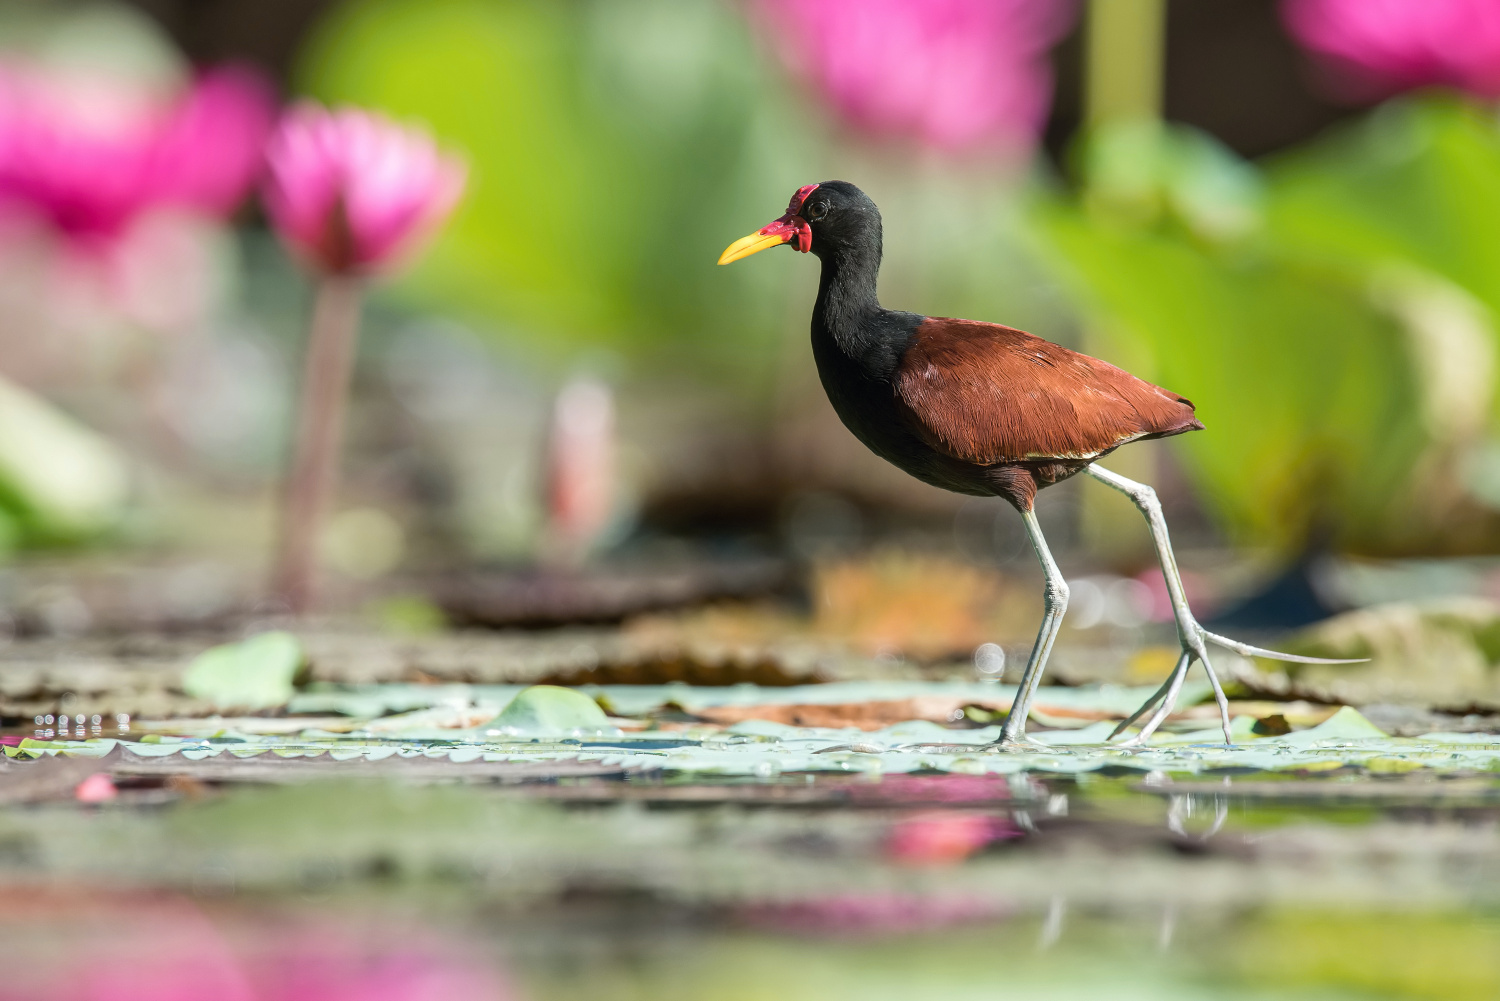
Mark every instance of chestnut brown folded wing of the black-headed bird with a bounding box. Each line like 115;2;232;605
894;317;1203;465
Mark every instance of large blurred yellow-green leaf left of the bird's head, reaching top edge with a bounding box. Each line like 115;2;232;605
302;0;803;390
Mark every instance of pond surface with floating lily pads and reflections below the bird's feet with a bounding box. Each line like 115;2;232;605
0;690;1500;1001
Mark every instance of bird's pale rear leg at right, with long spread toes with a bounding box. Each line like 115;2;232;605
1088;465;1358;743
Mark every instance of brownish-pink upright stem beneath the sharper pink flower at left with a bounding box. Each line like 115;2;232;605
272;275;360;615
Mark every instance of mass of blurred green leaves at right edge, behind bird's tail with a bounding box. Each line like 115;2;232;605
1032;98;1500;551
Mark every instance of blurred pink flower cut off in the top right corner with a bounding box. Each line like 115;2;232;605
1281;0;1500;101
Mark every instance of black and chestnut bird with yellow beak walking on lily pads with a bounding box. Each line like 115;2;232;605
719;180;1352;747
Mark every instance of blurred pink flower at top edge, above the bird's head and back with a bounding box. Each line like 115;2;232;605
758;0;1074;150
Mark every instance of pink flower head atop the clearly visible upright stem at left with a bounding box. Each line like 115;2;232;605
266;102;465;275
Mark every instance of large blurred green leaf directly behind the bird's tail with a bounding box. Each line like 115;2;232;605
1038;204;1425;549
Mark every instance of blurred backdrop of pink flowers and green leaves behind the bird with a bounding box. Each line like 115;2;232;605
0;0;1500;659
